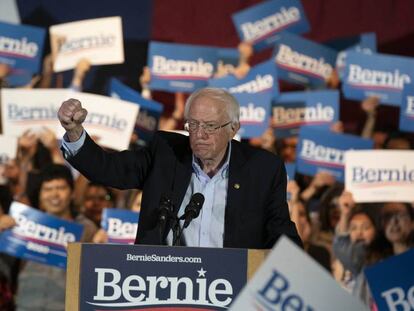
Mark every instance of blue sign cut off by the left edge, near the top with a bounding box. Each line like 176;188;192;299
0;22;46;73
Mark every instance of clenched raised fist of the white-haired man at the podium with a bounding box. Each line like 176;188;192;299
58;98;88;141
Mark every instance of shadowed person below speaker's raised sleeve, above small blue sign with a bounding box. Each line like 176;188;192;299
82;182;115;227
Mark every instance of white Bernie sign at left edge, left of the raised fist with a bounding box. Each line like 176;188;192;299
1;89;69;136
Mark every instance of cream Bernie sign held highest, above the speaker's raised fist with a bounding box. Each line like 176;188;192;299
49;16;124;72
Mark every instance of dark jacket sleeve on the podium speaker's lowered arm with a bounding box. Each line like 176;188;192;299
266;160;303;248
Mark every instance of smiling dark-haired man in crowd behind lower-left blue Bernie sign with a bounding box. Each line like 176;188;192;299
4;164;97;311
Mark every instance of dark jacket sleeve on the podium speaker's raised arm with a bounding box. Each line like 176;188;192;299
67;134;153;189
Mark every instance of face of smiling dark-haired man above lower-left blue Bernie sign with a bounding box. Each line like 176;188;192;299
39;179;72;218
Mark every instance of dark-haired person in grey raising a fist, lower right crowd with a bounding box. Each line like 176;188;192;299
333;191;390;306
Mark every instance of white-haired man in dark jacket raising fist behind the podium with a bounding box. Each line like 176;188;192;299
58;88;302;249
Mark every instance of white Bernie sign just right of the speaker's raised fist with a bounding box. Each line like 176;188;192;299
58;92;140;151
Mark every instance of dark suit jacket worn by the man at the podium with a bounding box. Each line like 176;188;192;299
68;132;301;249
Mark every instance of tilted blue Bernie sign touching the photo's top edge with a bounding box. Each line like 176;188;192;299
232;0;310;51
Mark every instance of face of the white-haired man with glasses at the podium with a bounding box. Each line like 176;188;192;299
188;97;235;166
